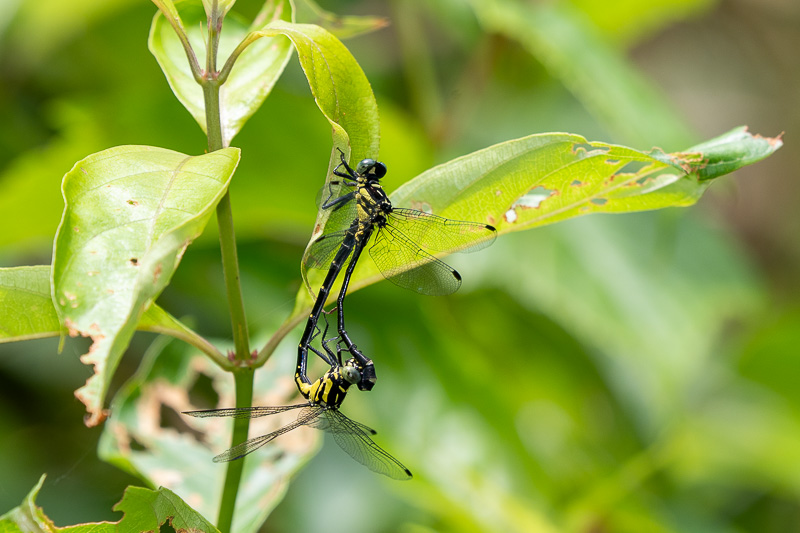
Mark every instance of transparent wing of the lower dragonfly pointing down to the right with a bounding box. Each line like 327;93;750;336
324;409;411;480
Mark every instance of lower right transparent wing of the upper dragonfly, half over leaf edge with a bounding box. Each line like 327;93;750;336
369;225;461;296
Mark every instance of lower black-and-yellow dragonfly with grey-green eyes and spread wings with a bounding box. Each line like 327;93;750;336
183;320;412;480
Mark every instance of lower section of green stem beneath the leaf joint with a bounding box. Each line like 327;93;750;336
217;367;254;532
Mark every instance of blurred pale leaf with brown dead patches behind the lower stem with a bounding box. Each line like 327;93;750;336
98;338;314;531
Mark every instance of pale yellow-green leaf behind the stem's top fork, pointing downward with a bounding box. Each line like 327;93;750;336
148;0;292;146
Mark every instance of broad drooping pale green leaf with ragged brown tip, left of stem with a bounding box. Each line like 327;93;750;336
53;146;239;426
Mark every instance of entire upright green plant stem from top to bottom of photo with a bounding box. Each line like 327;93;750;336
203;1;253;532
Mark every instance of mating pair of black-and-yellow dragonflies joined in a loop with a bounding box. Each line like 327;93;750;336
186;150;497;479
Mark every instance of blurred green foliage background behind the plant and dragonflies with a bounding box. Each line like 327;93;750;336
0;0;800;533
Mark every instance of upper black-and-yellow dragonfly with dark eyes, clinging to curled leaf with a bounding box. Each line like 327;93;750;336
298;150;497;390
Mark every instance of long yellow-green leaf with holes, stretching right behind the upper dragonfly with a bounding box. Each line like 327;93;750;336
292;128;782;317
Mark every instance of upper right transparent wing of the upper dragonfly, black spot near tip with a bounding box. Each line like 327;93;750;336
387;208;497;252
